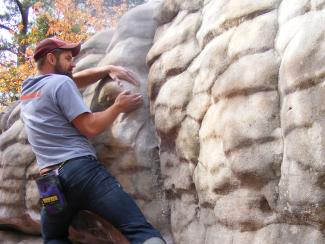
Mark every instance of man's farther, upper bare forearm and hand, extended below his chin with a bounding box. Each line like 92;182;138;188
73;65;140;88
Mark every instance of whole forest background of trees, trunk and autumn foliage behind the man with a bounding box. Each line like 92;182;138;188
0;0;146;112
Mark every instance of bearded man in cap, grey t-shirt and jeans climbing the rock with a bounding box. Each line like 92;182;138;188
21;38;165;244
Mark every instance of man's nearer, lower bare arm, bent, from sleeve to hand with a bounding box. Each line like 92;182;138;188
72;91;142;138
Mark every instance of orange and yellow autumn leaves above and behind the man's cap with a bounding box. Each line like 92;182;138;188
0;0;128;106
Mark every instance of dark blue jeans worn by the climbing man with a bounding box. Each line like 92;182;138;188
41;156;162;244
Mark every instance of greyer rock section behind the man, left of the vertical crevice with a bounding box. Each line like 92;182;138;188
0;2;171;244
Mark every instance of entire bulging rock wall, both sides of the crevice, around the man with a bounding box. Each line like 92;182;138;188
0;0;325;244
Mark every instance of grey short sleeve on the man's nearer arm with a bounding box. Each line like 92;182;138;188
54;79;91;122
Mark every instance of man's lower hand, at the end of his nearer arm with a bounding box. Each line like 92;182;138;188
113;91;142;113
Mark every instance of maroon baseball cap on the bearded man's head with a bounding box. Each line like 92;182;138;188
34;37;81;61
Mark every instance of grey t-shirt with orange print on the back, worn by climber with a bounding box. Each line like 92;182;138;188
21;74;96;169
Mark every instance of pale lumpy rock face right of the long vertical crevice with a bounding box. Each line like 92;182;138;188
147;0;325;244
